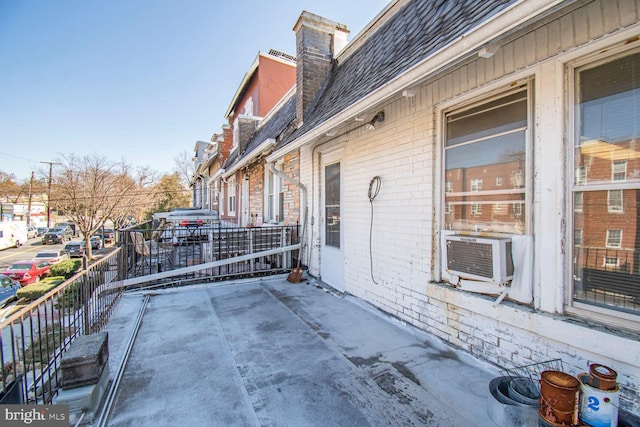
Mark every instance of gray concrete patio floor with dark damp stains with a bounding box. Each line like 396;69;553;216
97;276;498;427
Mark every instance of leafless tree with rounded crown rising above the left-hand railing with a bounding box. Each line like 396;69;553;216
52;155;135;259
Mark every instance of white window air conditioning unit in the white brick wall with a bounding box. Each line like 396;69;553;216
443;234;513;285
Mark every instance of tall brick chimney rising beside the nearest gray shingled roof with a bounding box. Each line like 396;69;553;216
293;11;349;126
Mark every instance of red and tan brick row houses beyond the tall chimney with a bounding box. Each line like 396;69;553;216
194;50;296;227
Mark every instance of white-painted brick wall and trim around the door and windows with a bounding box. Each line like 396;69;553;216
301;0;640;415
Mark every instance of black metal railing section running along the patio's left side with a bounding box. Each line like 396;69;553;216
0;252;122;404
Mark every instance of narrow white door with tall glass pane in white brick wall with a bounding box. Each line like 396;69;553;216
320;152;345;291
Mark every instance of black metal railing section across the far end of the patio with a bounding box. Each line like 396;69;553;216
118;222;299;284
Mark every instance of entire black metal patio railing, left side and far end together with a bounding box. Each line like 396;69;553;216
0;222;300;404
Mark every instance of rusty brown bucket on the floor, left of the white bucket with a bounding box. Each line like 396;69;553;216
539;371;580;425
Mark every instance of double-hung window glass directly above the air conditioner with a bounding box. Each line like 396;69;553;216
443;82;531;235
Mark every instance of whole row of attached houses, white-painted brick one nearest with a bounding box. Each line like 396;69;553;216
195;0;640;415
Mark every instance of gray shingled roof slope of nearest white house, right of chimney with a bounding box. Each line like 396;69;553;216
277;0;518;148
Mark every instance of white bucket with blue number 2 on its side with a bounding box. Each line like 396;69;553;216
578;373;620;427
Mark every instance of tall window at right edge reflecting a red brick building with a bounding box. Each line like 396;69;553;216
569;50;640;316
